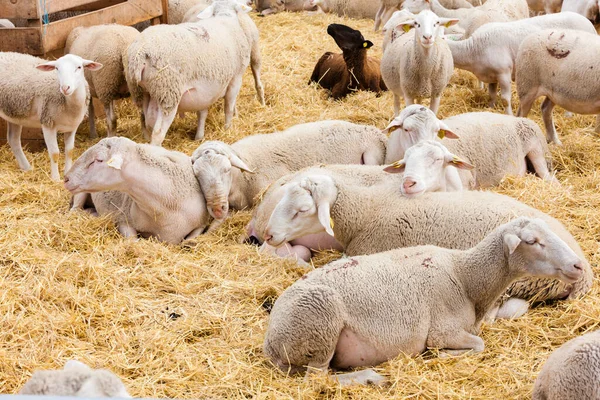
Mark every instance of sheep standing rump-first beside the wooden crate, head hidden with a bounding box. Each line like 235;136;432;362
65;24;140;138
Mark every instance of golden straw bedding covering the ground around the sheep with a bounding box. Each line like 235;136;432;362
0;13;600;399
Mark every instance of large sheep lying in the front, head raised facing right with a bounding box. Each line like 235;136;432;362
263;218;583;385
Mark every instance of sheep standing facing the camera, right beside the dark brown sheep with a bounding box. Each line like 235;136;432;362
381;10;458;115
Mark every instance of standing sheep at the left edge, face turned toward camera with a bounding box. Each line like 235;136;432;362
0;52;102;181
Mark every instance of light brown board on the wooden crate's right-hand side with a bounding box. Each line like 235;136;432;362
43;0;162;52
